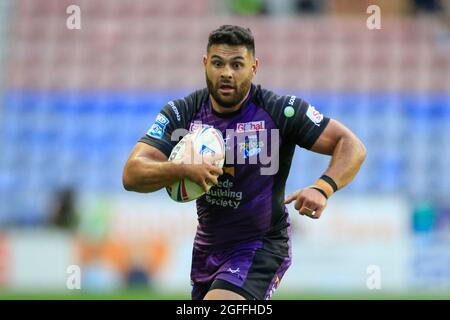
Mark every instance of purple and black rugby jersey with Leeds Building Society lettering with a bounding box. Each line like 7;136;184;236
139;85;329;251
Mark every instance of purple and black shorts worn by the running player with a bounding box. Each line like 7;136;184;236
191;230;291;300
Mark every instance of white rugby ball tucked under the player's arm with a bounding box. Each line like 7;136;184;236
166;127;225;202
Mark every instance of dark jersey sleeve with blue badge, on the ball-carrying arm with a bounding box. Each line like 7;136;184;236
139;101;184;157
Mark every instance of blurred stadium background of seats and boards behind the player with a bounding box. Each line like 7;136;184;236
0;0;450;299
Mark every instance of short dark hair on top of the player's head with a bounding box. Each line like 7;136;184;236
207;25;255;56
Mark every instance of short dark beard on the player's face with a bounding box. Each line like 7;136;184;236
205;72;252;108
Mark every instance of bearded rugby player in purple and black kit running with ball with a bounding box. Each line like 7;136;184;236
123;25;366;300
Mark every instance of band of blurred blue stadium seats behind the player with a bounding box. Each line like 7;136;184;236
0;90;450;220
